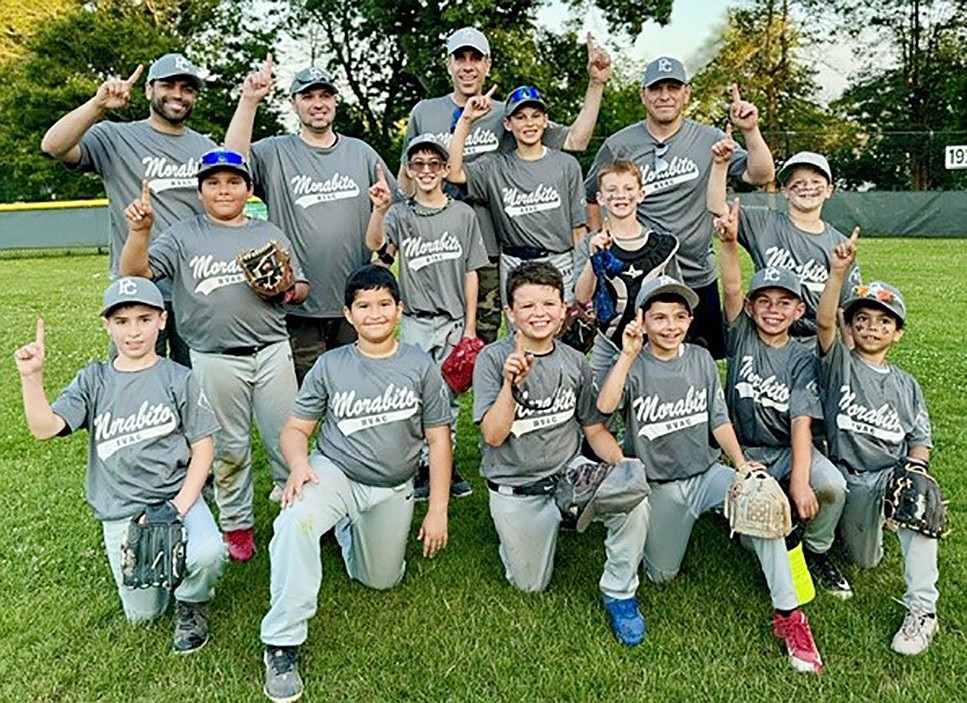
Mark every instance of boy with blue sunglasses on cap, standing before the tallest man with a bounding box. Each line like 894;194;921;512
447;86;586;305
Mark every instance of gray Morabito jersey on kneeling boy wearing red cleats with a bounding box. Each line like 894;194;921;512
625;344;729;481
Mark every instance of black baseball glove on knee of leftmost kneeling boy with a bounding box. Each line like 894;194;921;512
121;501;188;590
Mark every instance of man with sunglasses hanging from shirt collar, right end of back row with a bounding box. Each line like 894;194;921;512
585;56;775;359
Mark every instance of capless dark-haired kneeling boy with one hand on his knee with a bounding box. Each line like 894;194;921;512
261;265;452;703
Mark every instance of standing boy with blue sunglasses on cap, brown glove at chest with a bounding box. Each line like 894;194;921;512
120;149;309;561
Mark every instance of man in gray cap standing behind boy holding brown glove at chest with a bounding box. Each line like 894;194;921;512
225;56;396;385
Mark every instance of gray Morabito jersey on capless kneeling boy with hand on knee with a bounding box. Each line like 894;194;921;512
292;343;450;487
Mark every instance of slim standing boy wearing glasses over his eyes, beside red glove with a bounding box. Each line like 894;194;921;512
366;134;487;500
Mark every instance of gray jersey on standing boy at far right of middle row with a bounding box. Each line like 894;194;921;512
739;207;861;337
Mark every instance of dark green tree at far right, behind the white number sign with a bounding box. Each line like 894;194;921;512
809;0;967;190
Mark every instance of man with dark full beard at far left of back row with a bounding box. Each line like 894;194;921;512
40;54;215;366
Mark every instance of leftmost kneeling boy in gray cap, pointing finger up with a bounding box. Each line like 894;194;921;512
14;278;227;653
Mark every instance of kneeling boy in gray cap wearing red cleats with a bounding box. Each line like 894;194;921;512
598;276;823;673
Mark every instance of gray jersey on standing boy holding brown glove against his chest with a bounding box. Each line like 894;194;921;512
148;215;305;353
